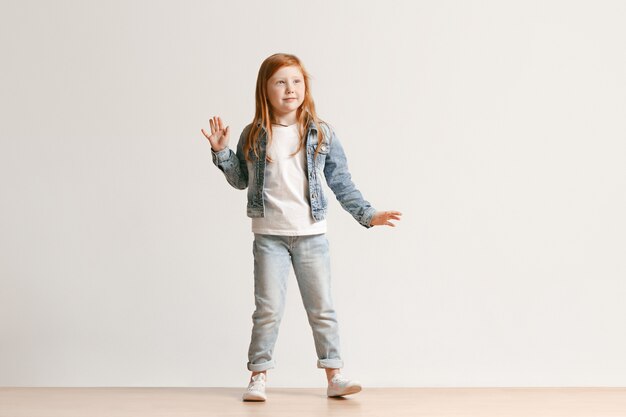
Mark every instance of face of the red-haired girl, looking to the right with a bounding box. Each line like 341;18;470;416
267;66;305;120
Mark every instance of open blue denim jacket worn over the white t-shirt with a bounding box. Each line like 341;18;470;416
211;122;376;228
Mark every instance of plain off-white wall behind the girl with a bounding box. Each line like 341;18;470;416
0;0;626;386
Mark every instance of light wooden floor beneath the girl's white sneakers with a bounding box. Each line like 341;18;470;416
0;388;626;417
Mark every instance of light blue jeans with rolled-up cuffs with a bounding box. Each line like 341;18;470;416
248;234;343;372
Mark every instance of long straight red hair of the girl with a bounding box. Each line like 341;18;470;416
243;53;324;162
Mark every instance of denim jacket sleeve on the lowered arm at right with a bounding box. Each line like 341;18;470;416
324;130;376;228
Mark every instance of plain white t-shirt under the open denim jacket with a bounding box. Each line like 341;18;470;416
252;124;326;236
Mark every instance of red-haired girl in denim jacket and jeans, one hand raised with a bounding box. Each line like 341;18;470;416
201;54;401;401
